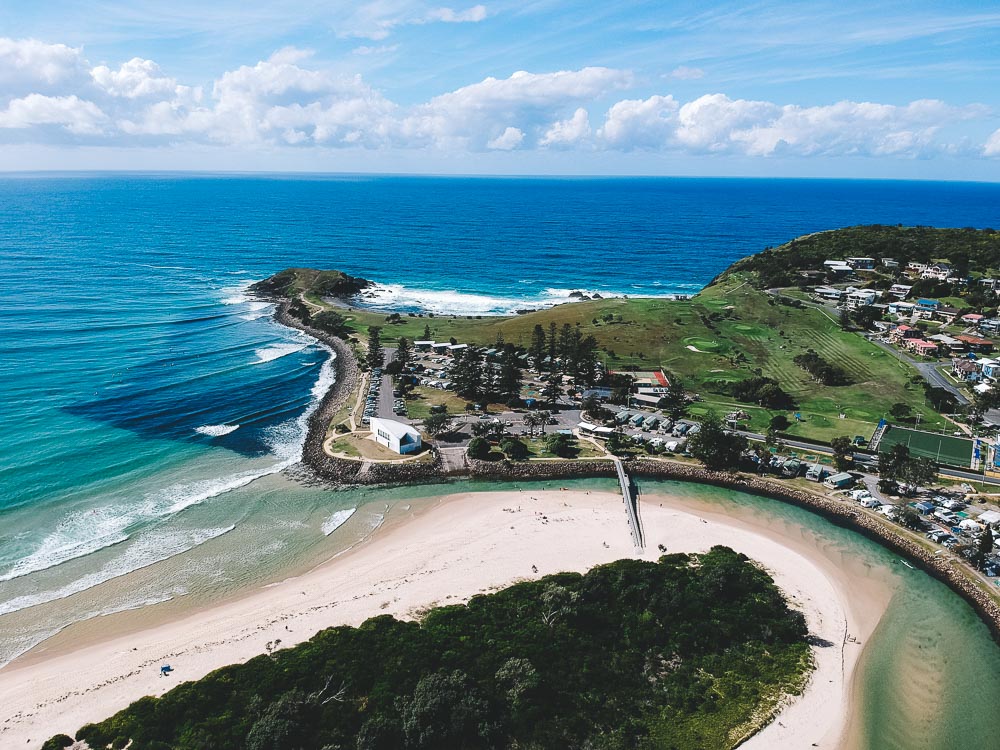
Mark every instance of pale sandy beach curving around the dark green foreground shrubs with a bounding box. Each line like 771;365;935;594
0;489;891;750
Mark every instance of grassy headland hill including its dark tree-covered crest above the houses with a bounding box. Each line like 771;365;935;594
258;226;984;441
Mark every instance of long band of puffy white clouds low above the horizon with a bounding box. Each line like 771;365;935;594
0;39;1000;163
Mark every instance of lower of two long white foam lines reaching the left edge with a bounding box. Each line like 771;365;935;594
0;524;236;615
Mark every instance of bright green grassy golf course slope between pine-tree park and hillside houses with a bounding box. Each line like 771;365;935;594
292;273;947;441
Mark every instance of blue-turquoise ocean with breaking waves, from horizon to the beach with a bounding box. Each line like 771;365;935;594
0;174;1000;748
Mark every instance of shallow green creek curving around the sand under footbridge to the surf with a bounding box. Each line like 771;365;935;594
0;476;1000;750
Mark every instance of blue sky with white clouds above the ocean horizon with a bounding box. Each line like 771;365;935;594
0;0;1000;180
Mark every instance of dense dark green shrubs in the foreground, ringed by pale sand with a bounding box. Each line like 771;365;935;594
64;547;809;750
